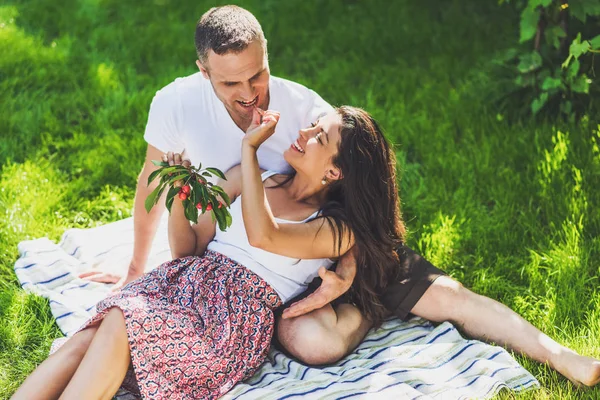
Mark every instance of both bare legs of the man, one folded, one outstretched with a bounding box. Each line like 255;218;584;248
278;276;600;386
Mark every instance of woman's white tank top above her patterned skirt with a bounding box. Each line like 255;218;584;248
208;171;333;303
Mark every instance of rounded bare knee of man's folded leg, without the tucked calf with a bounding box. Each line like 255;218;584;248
277;306;346;365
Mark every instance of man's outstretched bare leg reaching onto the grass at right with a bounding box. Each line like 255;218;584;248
411;276;600;386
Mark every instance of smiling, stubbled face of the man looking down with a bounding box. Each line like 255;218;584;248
196;41;270;131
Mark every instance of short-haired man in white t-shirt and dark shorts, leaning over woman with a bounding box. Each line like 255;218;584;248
85;6;600;384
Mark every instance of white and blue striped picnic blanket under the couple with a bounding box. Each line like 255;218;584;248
15;218;539;400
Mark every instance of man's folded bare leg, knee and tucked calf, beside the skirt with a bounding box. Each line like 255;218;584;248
277;304;371;365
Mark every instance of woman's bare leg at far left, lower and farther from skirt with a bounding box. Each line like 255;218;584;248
11;327;98;400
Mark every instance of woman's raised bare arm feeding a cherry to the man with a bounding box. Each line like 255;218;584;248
242;112;354;258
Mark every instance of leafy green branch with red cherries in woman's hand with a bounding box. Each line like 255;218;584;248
144;160;231;231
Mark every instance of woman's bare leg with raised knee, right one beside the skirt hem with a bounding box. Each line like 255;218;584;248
60;307;130;400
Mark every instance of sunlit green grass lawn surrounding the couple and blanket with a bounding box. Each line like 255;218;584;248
0;0;600;399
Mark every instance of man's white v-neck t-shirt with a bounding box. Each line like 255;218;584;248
144;72;333;172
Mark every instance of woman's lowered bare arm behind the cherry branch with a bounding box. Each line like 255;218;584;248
169;166;241;258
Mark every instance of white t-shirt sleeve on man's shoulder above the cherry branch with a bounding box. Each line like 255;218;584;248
144;86;184;153
